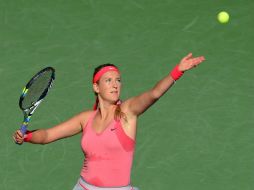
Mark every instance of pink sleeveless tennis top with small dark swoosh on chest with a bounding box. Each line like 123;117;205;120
80;111;135;187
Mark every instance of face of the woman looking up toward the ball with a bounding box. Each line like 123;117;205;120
96;71;121;103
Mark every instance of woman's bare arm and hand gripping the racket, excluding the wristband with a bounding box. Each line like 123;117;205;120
13;111;91;144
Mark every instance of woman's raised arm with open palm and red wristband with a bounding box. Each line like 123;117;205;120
122;53;205;116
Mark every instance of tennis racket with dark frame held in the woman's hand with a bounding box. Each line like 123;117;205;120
19;67;55;135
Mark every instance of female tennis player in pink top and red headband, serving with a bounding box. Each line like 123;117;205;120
13;53;205;190
